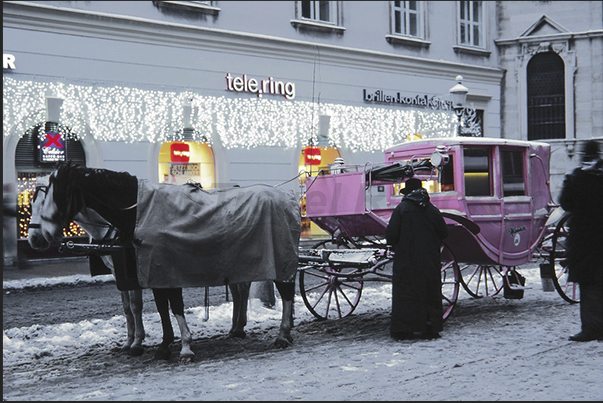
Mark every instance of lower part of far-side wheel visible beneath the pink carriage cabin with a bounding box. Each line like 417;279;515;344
461;264;504;298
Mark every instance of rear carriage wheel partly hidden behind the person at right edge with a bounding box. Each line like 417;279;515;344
549;214;580;303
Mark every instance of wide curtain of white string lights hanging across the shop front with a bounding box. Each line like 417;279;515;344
3;77;457;152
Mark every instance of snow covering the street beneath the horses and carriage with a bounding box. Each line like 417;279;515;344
3;268;603;401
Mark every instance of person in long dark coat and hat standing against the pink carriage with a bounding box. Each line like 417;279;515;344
385;178;448;340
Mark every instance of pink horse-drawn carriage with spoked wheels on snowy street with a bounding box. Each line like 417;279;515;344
299;137;579;319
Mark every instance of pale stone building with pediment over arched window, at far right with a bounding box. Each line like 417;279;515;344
494;1;603;194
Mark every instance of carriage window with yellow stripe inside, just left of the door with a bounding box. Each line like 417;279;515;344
463;147;492;196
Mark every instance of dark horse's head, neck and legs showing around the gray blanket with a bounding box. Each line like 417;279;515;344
30;163;295;361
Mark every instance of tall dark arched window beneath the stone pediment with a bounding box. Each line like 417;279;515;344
527;52;565;140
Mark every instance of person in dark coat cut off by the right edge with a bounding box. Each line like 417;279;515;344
559;140;603;341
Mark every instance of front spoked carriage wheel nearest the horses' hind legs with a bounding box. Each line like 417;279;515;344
299;240;363;320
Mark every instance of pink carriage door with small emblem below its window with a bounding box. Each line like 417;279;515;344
500;147;532;265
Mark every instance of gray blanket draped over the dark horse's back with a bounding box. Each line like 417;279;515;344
134;180;301;288
